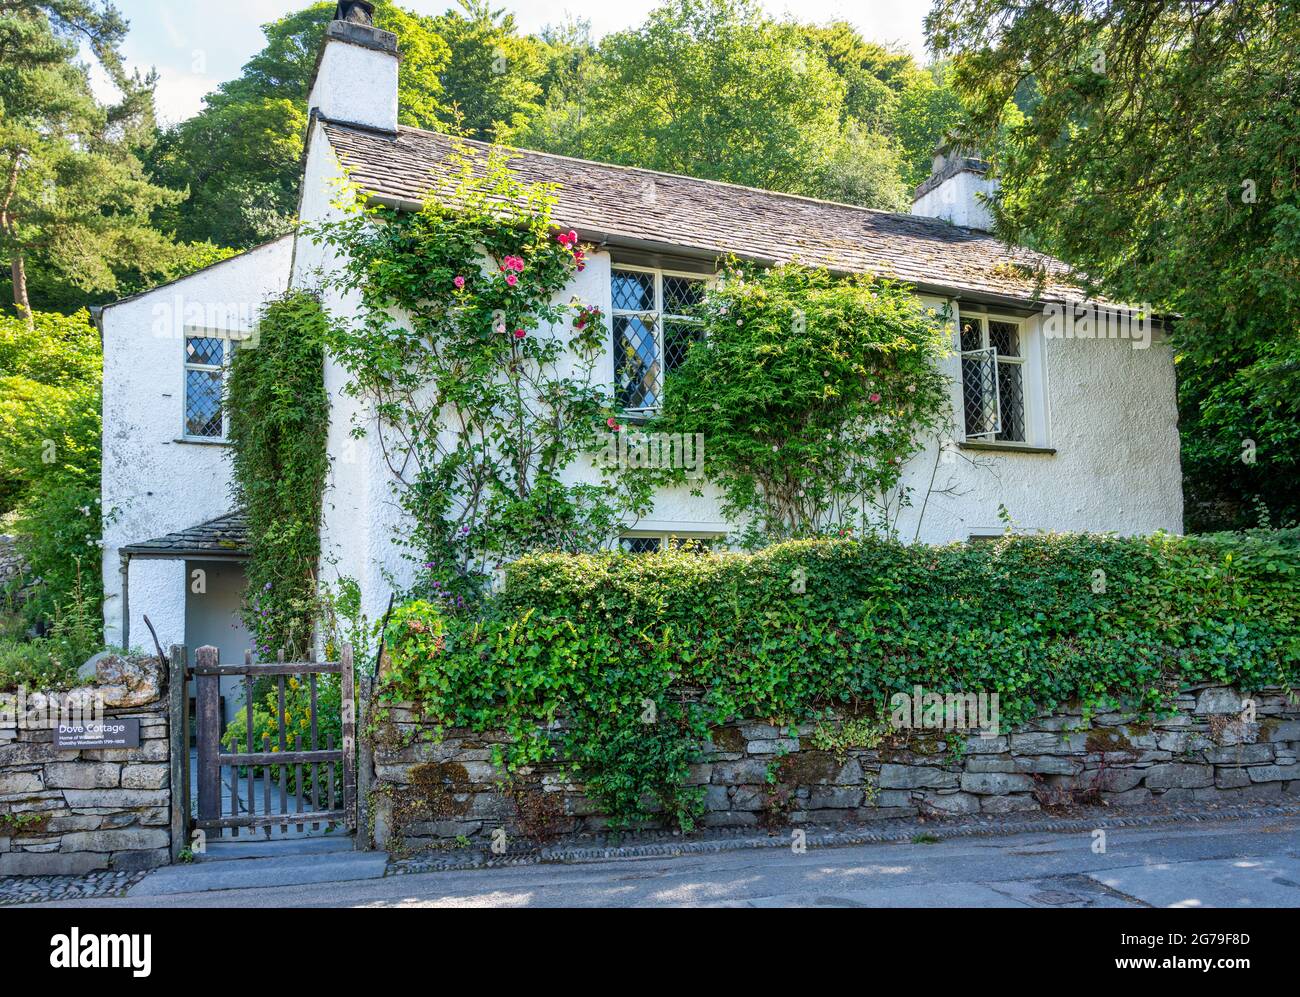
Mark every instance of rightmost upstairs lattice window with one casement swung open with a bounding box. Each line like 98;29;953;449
961;315;1026;443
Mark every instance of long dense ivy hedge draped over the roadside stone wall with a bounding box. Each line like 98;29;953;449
385;532;1300;827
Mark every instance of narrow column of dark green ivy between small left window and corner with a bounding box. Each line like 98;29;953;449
228;291;330;658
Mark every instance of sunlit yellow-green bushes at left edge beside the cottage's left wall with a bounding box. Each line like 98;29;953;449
0;312;103;629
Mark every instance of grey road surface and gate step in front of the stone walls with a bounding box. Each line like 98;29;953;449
27;816;1300;909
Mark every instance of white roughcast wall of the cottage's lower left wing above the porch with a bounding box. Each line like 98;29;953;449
100;237;293;646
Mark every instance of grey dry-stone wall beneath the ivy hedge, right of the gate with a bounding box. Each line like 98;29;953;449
371;685;1300;853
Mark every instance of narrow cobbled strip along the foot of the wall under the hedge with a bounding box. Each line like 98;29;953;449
387;799;1300;876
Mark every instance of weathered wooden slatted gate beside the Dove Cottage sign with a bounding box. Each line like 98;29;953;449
191;647;356;837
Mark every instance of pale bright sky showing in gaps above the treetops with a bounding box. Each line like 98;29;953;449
96;0;930;123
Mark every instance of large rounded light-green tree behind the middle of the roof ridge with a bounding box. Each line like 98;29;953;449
521;0;898;208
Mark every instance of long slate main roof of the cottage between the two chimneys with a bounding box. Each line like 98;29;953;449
322;120;1086;308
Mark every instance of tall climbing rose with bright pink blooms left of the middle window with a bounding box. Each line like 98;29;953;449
312;136;650;604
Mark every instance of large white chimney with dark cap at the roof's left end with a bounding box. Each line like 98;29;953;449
307;0;398;133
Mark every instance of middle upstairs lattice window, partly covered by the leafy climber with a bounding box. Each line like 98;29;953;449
612;266;709;415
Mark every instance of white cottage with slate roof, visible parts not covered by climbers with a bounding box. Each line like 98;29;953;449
101;0;1183;659
